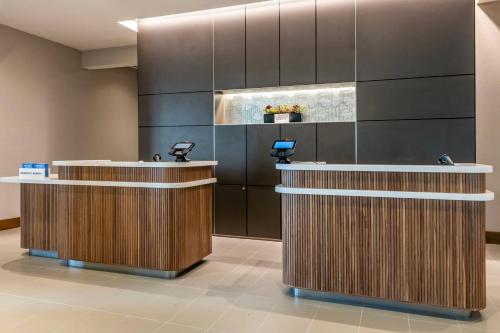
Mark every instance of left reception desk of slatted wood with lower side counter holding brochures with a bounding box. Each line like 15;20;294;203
0;161;217;277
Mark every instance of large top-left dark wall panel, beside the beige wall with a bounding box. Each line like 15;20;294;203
137;14;213;95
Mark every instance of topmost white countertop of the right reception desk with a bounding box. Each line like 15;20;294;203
276;162;493;173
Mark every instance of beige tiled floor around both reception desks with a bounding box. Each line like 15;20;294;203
0;229;500;333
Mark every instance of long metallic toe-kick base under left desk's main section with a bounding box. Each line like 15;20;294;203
66;260;180;279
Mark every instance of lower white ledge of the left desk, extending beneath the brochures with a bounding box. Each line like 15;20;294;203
0;175;217;189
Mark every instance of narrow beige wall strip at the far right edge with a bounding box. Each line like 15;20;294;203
476;2;500;231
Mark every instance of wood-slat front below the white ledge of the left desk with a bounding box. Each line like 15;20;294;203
17;168;213;270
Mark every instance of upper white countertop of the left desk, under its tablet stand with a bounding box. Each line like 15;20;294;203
52;160;217;168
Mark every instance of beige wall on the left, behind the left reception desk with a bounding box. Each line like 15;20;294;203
0;25;138;219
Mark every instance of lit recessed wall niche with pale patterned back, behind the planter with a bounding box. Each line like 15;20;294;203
215;83;356;125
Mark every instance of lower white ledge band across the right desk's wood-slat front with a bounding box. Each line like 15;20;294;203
276;185;495;201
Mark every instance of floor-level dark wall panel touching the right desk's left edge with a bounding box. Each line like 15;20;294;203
247;186;281;239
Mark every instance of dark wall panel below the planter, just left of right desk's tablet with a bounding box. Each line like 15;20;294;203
247;124;280;185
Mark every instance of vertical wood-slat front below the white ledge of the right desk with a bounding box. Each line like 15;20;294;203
282;194;486;309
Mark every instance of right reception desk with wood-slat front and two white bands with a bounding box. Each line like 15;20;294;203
276;163;494;316
